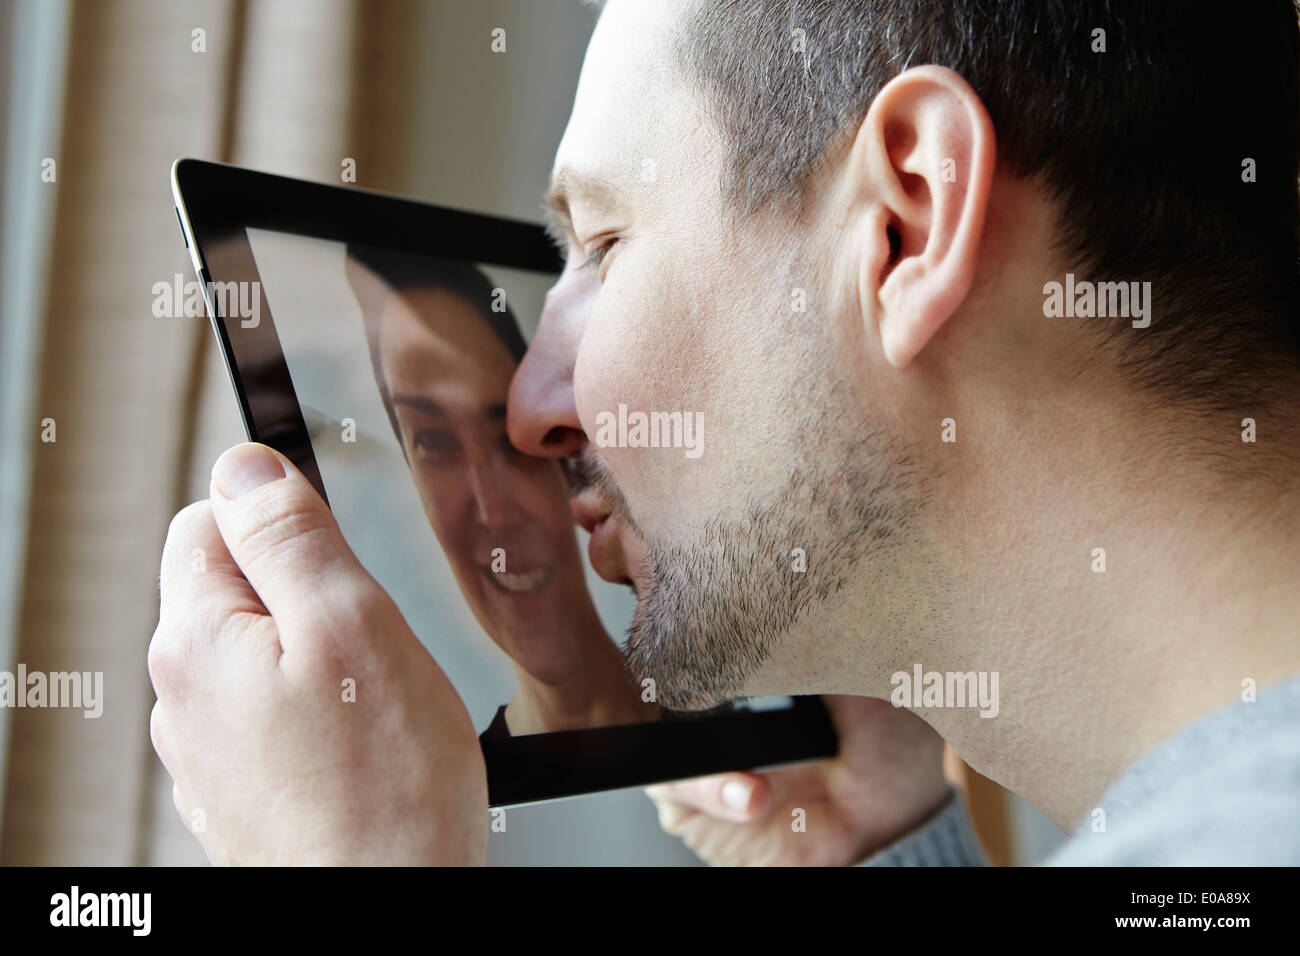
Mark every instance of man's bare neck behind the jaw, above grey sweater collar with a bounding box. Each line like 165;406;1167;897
917;400;1300;829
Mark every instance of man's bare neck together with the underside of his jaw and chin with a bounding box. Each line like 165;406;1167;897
746;382;1300;829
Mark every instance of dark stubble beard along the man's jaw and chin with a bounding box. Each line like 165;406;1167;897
576;385;920;710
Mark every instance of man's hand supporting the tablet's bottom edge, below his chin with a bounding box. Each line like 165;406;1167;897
646;696;948;866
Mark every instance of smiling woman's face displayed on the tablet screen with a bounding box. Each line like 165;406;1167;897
380;289;588;682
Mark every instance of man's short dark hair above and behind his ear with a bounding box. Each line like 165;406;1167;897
673;0;1300;410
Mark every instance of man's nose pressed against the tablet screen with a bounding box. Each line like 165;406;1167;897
506;272;599;458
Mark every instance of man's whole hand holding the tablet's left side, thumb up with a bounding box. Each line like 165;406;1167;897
148;445;488;864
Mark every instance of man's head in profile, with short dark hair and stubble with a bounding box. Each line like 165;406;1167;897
510;0;1297;706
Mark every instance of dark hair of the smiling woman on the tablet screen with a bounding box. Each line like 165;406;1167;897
347;243;528;455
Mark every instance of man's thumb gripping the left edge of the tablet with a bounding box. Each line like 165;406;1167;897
212;442;371;631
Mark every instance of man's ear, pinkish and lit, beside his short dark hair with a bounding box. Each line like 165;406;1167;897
849;66;997;368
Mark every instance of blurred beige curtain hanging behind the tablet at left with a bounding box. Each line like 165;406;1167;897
0;0;417;865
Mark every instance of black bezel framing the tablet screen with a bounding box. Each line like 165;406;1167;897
172;159;837;806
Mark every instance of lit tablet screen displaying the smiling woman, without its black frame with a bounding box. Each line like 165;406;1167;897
247;229;789;736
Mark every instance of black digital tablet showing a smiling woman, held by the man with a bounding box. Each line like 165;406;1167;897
172;159;836;806
